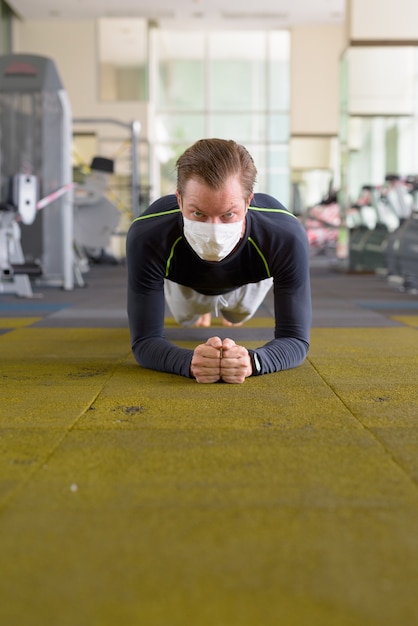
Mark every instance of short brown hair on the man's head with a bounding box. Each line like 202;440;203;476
176;139;257;198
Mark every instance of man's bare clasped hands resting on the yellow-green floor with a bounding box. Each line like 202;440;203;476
190;337;252;383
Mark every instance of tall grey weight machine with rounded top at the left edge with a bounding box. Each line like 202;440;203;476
0;54;76;296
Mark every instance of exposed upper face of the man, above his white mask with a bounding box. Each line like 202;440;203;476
176;176;252;233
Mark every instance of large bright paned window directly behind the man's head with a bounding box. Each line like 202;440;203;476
152;29;290;200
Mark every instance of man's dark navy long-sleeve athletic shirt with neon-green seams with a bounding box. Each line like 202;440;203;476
126;193;312;377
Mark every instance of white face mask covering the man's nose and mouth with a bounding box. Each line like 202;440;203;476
183;216;244;261
